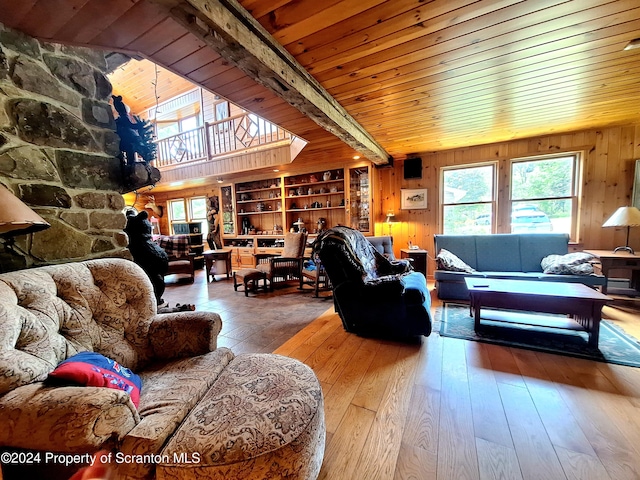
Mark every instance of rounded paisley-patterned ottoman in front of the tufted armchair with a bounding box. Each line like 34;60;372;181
157;354;325;480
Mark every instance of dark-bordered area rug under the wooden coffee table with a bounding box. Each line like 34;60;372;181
435;303;640;367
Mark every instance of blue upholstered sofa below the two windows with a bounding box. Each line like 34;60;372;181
434;233;606;300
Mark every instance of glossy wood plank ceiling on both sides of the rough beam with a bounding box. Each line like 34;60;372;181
0;0;640;165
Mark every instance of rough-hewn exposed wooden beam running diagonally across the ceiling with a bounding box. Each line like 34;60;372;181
156;0;392;165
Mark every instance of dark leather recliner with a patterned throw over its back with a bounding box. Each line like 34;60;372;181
313;226;432;339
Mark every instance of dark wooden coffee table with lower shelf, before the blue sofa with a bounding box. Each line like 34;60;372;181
465;277;611;348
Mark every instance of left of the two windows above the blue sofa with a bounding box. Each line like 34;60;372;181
440;163;496;235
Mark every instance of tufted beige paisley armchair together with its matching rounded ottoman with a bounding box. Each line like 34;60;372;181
0;259;325;480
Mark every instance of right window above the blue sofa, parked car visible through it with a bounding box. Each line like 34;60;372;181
511;154;578;237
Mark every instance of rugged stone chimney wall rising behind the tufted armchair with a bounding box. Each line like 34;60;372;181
0;24;128;271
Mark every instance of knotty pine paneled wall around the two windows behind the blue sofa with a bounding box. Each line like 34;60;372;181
376;123;640;274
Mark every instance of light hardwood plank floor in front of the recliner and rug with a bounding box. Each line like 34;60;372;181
166;274;640;480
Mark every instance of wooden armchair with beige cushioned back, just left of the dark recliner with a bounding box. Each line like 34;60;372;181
254;233;307;291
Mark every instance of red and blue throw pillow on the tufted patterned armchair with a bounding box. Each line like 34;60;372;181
49;352;142;407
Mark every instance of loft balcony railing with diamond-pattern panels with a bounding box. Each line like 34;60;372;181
155;113;292;168
